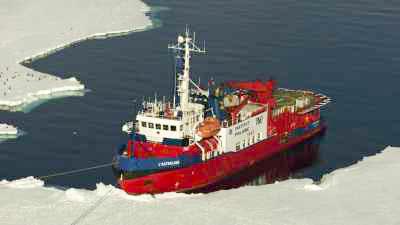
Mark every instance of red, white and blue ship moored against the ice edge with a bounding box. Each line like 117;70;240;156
113;29;331;194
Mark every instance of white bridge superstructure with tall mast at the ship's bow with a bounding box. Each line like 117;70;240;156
125;29;208;142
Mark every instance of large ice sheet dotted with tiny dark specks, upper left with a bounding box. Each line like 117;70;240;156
0;0;151;110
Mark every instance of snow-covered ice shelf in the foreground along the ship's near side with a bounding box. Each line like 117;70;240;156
0;147;400;225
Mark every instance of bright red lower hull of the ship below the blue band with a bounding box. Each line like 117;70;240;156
118;124;325;194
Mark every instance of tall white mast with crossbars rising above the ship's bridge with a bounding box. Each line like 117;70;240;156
168;28;206;114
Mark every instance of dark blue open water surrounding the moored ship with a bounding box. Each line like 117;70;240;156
0;0;400;188
